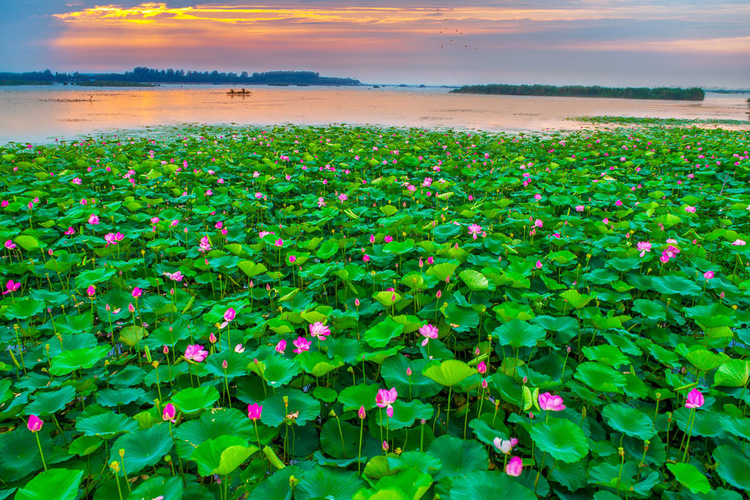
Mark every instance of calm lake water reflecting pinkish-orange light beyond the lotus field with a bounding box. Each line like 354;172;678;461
0;85;750;144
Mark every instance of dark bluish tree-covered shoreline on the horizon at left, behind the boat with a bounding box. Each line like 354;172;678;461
0;67;360;85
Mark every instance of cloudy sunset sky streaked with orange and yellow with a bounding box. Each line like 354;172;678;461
0;0;750;88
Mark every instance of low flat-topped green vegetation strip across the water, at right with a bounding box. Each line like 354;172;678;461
451;84;704;101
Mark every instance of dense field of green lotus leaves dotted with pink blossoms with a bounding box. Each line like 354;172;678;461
0;122;750;500
